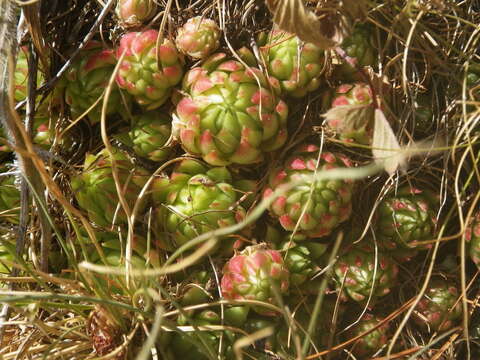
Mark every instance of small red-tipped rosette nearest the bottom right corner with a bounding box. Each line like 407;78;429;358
414;278;462;331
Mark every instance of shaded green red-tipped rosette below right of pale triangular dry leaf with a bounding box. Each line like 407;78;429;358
376;186;436;256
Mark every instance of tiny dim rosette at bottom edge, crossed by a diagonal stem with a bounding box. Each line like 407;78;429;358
346;313;389;359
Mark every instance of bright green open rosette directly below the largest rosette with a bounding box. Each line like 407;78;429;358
153;159;253;252
